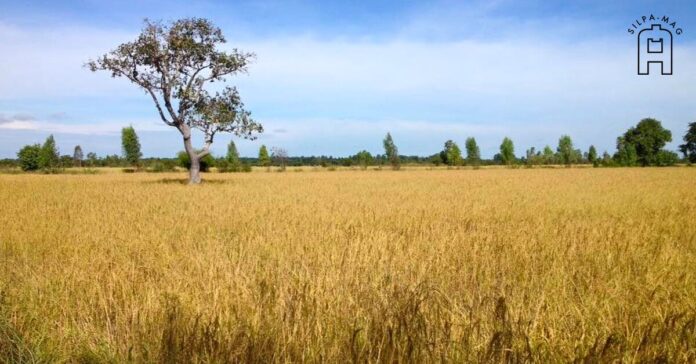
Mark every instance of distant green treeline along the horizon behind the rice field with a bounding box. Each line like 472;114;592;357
8;118;696;173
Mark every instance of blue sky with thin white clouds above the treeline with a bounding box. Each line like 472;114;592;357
0;0;696;158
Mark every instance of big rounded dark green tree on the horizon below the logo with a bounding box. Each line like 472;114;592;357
623;118;672;166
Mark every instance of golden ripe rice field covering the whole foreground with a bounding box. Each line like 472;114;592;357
0;167;696;363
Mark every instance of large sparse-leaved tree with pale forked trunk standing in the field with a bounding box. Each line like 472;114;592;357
87;18;263;184
